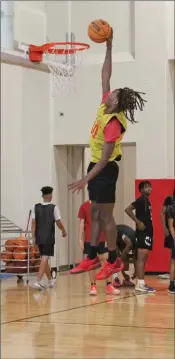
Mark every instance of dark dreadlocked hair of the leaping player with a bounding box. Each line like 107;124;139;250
117;87;147;123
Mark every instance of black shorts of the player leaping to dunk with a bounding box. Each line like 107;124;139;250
88;161;119;203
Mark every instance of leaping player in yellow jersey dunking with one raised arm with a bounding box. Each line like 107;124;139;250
68;29;145;280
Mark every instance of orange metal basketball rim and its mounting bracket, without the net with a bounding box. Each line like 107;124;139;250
29;41;90;62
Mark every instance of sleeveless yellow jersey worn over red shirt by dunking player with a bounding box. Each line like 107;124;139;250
90;103;127;163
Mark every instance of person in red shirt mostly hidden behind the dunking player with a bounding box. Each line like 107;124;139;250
78;201;120;295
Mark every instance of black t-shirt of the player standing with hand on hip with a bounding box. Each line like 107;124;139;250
132;196;153;237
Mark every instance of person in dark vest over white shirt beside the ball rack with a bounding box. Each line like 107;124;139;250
32;187;67;289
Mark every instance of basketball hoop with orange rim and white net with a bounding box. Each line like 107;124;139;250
29;42;90;96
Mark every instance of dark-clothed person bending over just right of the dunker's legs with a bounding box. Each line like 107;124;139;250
113;224;136;287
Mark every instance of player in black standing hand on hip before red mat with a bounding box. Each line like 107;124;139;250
125;181;155;293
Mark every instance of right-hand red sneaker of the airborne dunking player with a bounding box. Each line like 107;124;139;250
96;258;124;280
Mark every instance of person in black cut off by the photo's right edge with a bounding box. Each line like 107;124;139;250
168;189;175;294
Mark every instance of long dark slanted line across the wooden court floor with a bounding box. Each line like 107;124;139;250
1;288;166;325
